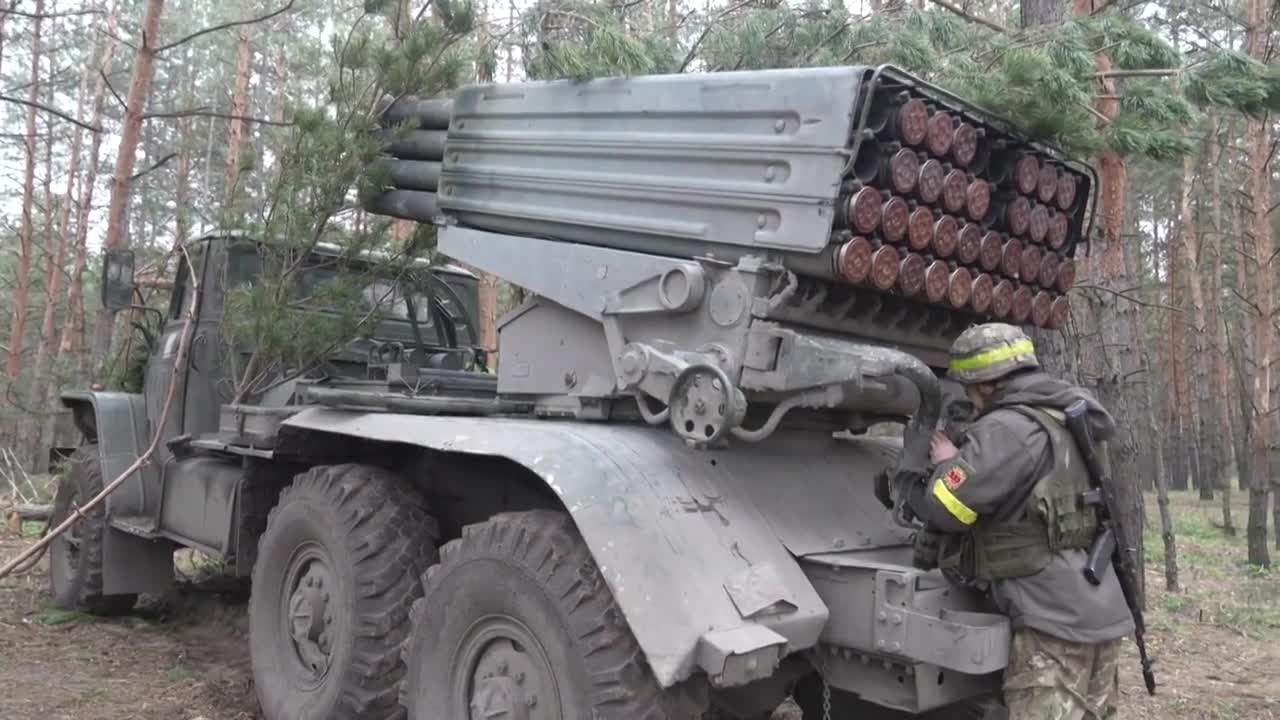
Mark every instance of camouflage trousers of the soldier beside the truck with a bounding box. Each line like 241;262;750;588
1004;628;1120;720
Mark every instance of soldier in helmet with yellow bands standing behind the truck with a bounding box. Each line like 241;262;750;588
908;323;1134;720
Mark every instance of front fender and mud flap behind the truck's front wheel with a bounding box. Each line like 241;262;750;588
61;391;173;594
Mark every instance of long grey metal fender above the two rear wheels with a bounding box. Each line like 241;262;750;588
282;409;909;687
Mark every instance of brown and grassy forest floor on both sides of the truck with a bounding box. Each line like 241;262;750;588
0;493;1280;720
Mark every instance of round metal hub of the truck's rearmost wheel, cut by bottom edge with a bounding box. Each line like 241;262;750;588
466;619;561;720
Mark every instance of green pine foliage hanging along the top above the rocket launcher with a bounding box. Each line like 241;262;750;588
524;0;1280;161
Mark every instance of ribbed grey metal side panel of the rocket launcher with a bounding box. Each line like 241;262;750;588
440;67;868;252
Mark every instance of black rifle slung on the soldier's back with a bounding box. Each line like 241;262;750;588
1065;400;1156;694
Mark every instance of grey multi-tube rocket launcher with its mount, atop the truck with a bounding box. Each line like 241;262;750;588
367;67;1096;443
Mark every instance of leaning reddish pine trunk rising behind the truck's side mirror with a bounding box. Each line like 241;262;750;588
92;0;164;374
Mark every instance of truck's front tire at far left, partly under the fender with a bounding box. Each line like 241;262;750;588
49;445;138;615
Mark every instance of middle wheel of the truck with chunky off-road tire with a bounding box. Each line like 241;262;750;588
250;465;438;720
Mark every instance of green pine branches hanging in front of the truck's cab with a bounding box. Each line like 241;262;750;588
217;0;476;401
